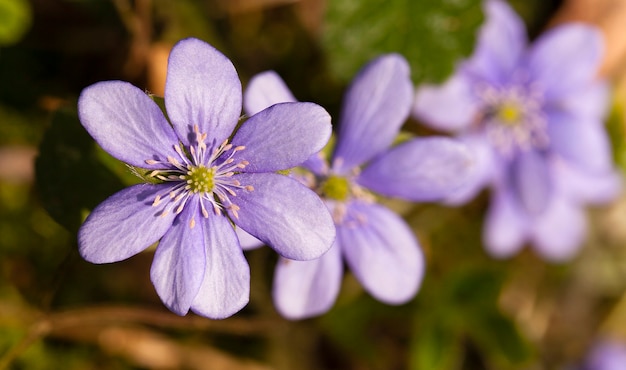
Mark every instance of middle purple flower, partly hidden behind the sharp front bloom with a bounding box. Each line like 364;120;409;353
244;55;472;319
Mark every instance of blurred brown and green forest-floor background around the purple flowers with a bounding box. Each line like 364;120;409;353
0;0;626;370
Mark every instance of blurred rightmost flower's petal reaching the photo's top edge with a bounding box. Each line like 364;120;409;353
464;0;527;84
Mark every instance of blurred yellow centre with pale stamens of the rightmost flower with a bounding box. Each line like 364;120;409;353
478;85;548;156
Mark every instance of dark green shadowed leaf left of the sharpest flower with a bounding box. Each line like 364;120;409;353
35;109;124;232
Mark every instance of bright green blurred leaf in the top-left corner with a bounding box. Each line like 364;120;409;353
0;0;31;45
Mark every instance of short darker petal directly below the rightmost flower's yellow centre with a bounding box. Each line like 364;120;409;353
509;150;554;215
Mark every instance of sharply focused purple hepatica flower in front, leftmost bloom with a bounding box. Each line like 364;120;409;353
78;39;335;318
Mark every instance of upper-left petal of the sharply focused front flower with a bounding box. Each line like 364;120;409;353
78;81;178;168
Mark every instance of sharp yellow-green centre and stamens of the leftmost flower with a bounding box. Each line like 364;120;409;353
146;125;254;228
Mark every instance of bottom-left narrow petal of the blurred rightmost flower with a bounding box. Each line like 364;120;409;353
483;186;528;258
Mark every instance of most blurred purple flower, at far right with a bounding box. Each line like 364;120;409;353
414;0;620;261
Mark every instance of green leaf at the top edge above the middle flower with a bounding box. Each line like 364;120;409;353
322;0;483;83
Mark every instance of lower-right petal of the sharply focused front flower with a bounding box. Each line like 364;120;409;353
231;173;335;260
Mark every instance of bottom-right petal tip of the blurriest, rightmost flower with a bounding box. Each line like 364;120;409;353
530;196;587;262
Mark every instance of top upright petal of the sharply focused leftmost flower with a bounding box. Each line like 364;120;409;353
165;38;242;145
